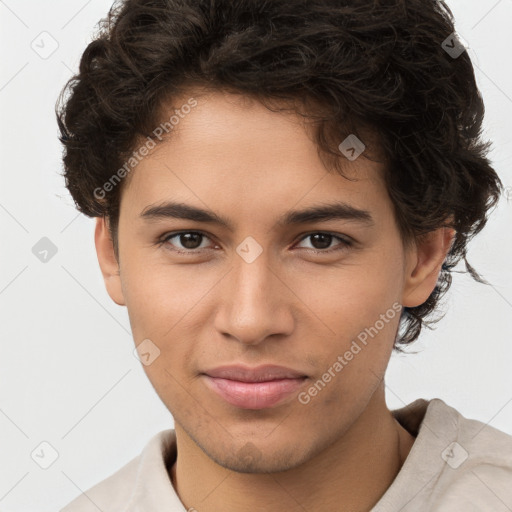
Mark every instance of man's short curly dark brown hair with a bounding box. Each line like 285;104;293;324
56;0;503;352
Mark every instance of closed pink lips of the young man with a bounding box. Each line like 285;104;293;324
203;365;308;409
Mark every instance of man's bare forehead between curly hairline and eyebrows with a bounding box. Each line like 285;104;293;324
121;91;387;220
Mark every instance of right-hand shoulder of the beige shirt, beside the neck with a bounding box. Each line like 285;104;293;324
372;398;512;512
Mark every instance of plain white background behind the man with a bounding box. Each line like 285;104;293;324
0;0;512;512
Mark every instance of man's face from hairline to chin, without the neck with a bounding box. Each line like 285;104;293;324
97;87;448;472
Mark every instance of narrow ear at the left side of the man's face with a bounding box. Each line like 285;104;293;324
94;217;126;306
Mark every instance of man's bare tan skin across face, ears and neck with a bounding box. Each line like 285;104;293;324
95;91;453;512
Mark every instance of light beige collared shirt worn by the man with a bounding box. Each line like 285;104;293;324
61;398;512;512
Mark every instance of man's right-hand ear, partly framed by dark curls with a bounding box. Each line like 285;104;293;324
402;227;455;308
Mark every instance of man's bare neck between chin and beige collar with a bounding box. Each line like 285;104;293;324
170;386;415;512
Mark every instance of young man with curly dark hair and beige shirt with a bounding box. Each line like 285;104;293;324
58;0;512;512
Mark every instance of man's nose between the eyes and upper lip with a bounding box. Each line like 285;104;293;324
215;246;295;345
